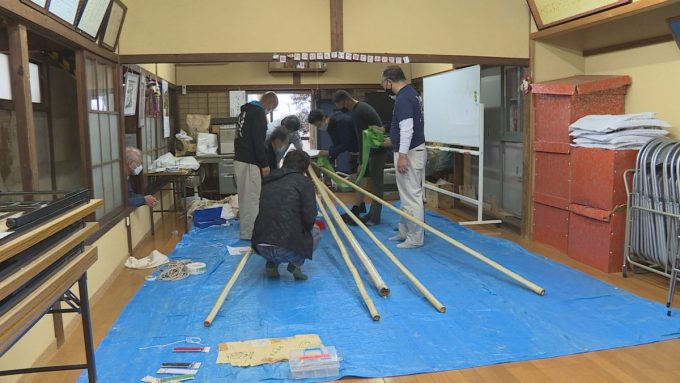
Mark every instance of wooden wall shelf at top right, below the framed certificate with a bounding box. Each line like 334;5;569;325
531;0;680;56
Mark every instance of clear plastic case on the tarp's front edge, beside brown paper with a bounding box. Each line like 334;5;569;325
288;346;340;379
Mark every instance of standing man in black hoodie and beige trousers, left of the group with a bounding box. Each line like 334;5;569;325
234;92;279;241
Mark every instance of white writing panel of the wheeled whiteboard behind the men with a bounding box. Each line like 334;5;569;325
423;65;481;147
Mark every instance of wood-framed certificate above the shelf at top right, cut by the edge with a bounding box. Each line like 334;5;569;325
527;0;633;30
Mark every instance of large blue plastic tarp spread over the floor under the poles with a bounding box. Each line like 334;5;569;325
79;209;680;382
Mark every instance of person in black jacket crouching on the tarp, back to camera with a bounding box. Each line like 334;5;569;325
252;150;321;280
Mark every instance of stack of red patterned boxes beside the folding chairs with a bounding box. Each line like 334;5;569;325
532;76;635;258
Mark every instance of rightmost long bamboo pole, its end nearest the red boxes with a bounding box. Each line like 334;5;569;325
312;163;545;295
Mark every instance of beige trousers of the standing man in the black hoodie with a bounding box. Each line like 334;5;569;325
234;161;262;241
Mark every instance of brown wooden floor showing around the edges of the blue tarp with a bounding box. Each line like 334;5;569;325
21;207;680;383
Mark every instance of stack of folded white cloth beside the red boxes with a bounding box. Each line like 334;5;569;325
569;112;671;149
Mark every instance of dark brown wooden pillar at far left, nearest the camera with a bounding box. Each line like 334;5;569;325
7;20;38;191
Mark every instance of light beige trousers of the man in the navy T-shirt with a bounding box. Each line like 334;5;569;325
394;144;427;245
